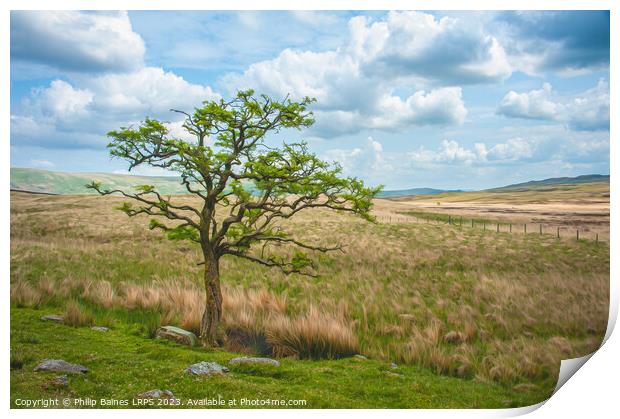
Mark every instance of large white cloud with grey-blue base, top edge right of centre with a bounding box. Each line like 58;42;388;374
350;11;512;85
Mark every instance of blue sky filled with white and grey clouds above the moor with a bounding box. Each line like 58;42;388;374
10;11;610;189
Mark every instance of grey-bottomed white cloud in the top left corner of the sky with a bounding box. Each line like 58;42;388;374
11;11;145;73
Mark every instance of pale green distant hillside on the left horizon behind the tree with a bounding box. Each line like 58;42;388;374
11;167;187;195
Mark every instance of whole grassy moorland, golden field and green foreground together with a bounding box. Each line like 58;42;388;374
11;193;609;407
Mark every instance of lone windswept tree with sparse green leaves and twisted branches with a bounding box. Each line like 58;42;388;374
87;90;380;346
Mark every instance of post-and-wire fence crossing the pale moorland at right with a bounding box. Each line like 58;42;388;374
377;213;607;244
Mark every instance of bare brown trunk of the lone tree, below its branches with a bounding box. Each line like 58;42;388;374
200;256;222;346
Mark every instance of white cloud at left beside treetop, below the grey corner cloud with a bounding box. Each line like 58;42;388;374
11;67;220;148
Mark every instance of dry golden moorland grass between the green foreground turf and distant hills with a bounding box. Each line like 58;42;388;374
11;194;609;386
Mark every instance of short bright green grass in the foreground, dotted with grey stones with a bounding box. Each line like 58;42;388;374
11;308;540;408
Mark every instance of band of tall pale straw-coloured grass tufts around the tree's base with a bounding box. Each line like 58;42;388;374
11;280;359;359
